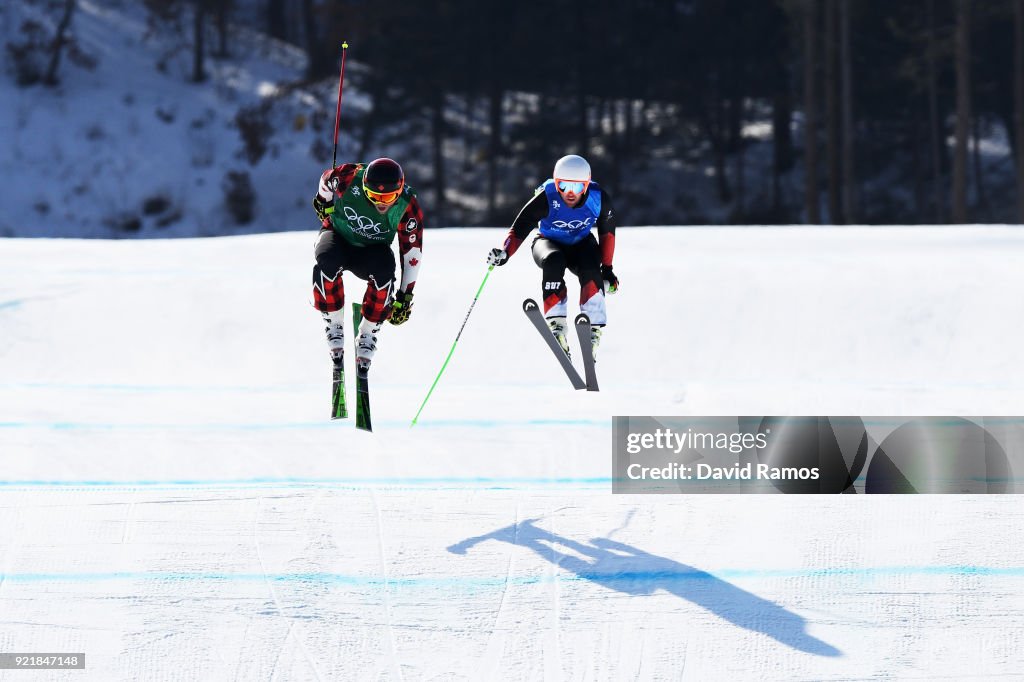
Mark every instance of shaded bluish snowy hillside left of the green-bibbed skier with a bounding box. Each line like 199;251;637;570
0;1;331;238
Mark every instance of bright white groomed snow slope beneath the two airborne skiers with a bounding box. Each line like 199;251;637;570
0;227;1024;680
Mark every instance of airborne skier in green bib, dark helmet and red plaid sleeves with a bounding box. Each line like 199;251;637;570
313;158;423;369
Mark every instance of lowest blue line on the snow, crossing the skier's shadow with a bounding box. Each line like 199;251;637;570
0;565;1024;589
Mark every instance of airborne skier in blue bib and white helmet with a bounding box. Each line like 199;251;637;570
487;154;618;358
